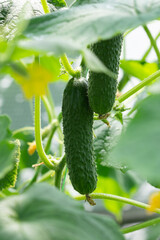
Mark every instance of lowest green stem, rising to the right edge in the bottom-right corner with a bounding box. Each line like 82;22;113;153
121;218;160;234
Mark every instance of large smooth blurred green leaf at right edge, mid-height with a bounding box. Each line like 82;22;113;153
110;94;160;185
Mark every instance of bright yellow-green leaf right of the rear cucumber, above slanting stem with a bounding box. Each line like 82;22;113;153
120;60;158;80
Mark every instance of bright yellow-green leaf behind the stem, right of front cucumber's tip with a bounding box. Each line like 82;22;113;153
96;177;129;219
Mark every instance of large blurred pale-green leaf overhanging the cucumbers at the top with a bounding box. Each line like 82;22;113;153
21;0;160;57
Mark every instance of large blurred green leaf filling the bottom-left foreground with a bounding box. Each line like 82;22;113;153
0;183;124;240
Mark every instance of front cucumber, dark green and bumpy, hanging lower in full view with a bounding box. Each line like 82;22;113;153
62;79;97;194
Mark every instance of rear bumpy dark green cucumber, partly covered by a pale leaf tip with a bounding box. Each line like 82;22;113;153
88;34;123;115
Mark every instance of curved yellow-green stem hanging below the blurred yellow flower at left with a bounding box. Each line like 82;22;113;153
35;96;55;170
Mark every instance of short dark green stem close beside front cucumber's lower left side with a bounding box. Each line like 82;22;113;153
55;155;66;189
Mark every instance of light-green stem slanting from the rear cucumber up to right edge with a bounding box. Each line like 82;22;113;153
118;70;160;103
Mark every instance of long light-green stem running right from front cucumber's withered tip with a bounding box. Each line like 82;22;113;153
75;193;160;214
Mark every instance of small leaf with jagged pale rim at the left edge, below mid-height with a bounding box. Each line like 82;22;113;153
0;140;20;190
